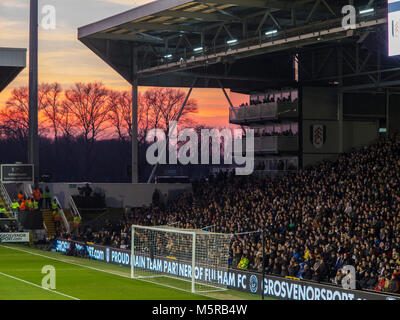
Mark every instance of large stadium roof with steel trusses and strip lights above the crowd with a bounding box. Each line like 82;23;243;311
78;0;390;92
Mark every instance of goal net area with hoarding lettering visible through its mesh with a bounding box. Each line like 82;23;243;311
131;225;232;293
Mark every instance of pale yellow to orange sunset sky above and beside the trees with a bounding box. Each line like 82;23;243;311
0;0;247;127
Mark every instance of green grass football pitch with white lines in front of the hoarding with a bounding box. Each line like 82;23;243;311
0;245;268;300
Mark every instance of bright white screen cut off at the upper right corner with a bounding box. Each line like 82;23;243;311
387;0;400;57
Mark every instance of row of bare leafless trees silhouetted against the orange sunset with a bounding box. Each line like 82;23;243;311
0;82;198;181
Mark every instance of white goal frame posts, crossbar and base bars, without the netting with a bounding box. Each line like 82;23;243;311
131;225;231;293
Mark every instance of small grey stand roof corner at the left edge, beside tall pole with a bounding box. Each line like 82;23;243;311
0;48;26;92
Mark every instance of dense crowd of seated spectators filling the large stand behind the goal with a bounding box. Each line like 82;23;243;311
75;135;400;293
